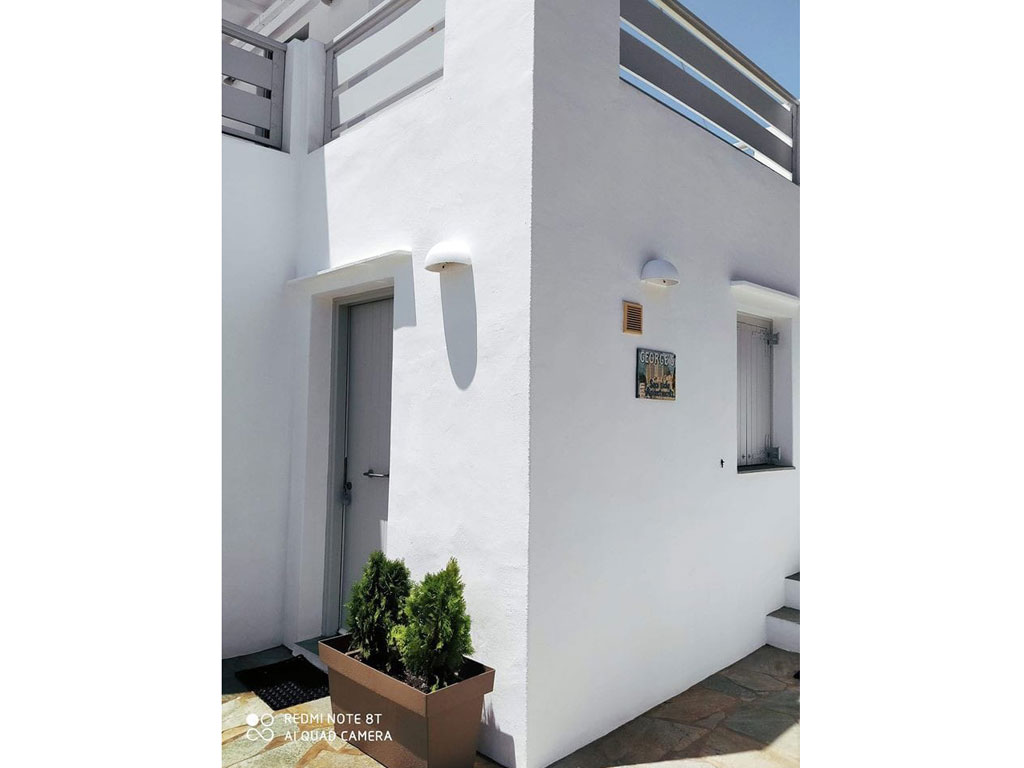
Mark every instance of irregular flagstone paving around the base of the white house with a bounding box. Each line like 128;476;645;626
221;645;800;768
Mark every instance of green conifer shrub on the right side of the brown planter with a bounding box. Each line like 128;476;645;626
393;557;473;690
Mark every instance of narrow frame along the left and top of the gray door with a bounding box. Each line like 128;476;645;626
321;288;394;636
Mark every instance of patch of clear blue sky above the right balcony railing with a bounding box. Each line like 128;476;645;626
682;0;800;98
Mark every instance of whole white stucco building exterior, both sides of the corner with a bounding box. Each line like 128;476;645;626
222;0;800;768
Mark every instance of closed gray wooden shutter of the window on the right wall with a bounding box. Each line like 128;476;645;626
736;313;779;468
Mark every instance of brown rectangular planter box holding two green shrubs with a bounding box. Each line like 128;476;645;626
319;635;495;768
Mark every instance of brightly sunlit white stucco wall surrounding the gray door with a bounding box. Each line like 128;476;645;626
285;0;534;765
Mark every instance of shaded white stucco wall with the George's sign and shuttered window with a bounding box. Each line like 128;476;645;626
527;0;799;768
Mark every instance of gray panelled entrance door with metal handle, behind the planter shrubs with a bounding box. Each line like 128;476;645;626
324;299;393;634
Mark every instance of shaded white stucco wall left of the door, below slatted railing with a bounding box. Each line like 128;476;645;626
223;136;297;657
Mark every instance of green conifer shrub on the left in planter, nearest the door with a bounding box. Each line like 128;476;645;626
348;551;412;673
